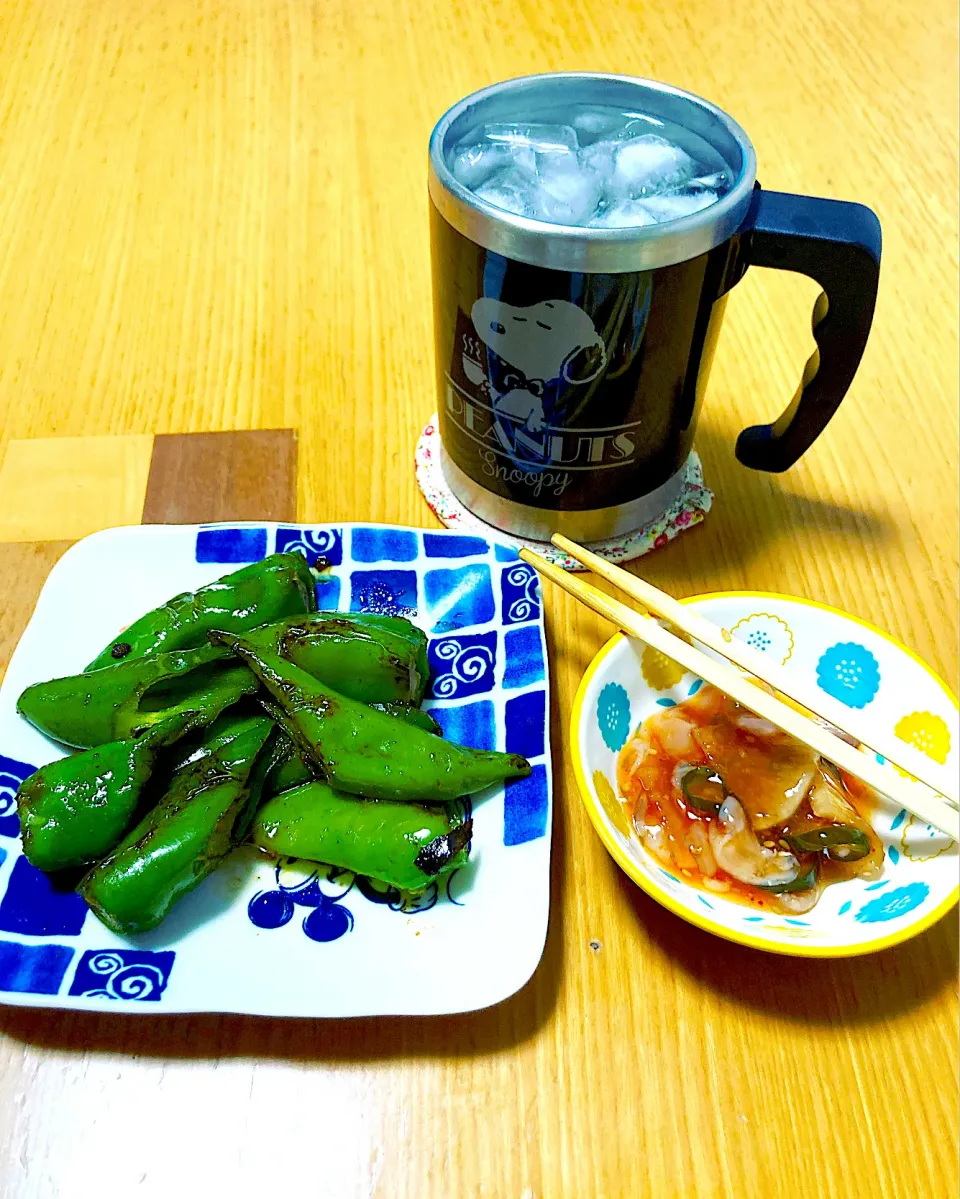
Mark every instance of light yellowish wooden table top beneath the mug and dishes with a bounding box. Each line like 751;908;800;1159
0;0;958;1199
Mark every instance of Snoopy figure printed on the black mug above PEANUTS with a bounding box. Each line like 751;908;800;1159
470;296;606;433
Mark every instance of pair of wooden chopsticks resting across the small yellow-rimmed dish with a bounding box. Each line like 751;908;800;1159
520;534;960;840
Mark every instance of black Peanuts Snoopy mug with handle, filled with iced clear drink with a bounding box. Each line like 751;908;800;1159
429;74;880;540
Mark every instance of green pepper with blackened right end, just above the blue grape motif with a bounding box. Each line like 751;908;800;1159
253;783;473;891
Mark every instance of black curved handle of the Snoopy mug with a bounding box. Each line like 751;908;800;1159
737;186;881;471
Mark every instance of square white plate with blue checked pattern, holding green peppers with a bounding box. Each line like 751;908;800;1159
0;523;551;1017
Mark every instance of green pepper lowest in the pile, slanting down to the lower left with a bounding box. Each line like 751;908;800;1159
78;716;273;935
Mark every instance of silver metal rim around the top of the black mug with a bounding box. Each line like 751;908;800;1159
428;71;756;275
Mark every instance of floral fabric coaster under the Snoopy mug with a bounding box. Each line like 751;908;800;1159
416;414;713;571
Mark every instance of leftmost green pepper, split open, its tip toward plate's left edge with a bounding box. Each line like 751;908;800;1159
17;645;259;749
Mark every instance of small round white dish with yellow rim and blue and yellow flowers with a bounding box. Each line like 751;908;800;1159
570;591;960;957
